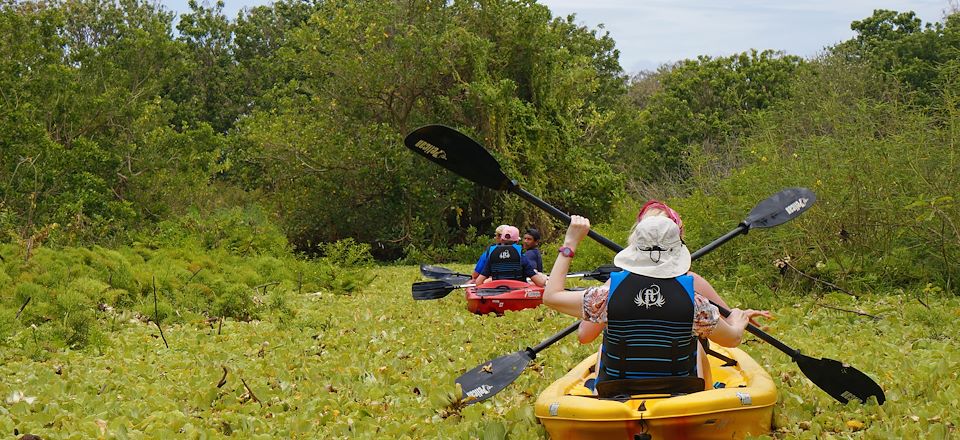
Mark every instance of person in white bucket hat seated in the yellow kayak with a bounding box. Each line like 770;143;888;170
543;215;769;392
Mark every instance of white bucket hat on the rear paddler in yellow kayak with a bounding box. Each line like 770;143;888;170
613;216;690;278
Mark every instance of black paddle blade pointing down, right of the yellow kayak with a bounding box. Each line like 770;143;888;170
793;354;886;404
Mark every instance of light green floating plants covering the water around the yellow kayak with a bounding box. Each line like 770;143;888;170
0;259;960;439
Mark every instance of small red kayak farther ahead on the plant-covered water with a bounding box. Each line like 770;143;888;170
466;280;543;316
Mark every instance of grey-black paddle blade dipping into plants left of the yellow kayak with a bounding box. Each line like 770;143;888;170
456;348;537;405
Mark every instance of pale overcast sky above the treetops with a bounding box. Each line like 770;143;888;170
160;0;950;73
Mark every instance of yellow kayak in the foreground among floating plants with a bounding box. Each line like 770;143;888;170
536;346;777;440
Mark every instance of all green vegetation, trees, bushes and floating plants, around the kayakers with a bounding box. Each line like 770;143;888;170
0;0;960;438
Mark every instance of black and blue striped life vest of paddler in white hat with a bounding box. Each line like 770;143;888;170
597;271;697;382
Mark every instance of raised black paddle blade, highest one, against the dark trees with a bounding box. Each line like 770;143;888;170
403;125;513;190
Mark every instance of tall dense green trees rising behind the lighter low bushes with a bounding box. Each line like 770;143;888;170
0;0;960;268
